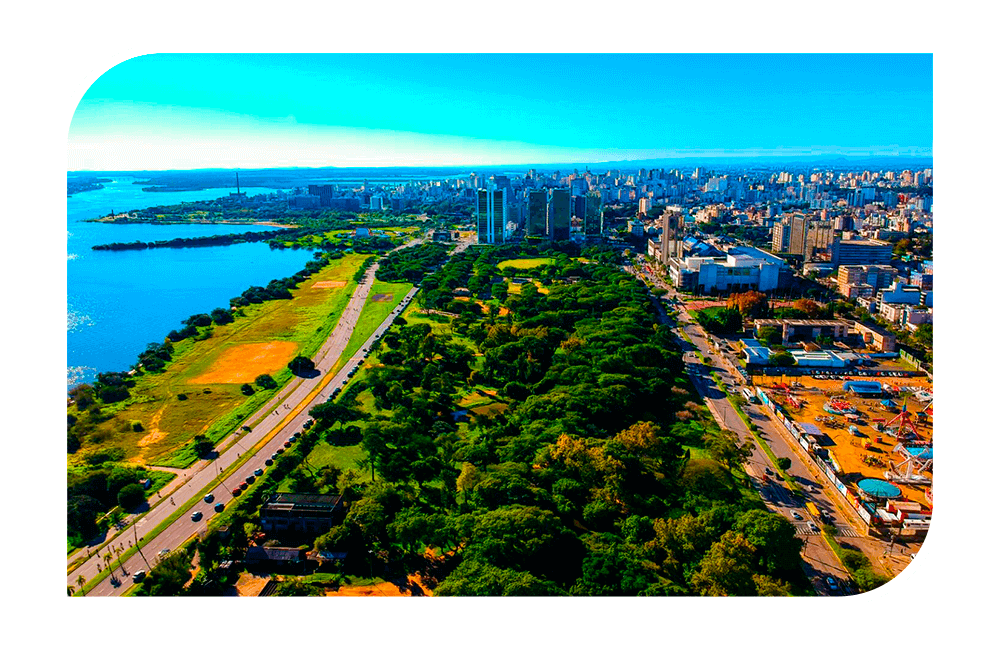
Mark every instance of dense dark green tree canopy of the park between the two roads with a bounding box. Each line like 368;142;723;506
172;246;808;596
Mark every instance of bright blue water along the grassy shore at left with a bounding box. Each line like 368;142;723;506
65;177;313;386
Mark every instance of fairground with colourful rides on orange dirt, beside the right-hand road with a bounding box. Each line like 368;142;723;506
754;376;934;530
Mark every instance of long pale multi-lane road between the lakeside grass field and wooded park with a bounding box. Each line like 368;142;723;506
67;232;470;596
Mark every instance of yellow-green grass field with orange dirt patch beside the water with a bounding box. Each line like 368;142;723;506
67;255;367;468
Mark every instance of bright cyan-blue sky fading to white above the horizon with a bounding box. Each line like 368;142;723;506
60;46;935;171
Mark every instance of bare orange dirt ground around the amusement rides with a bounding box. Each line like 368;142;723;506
754;370;933;506
